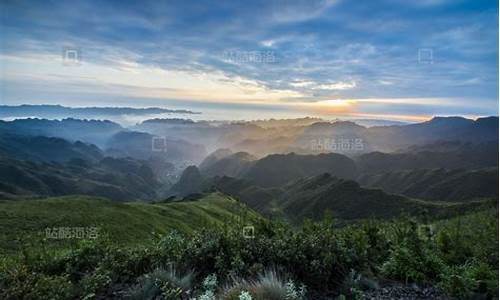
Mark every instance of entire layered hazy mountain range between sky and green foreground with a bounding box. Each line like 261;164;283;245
0;117;498;222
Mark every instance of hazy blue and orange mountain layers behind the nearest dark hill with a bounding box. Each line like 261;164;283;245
0;113;498;210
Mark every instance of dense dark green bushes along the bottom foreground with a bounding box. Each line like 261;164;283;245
0;211;498;300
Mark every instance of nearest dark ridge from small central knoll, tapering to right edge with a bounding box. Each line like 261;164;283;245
169;166;495;223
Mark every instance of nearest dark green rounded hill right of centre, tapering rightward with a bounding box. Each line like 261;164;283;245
278;174;496;221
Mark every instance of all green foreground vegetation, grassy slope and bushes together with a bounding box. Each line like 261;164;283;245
0;197;498;299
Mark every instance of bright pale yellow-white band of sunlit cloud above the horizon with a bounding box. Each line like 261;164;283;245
0;54;496;122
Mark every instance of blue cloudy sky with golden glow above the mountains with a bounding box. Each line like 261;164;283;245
0;0;499;121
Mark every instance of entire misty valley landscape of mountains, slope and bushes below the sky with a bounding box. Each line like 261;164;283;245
0;111;498;299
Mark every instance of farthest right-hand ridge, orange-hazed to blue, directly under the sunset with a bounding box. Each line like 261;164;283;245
295;117;499;155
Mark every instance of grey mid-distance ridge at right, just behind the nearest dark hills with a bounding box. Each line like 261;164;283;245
200;141;498;187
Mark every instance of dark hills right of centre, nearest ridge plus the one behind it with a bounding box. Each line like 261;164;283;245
171;166;498;223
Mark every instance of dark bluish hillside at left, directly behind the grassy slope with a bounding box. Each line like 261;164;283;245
0;157;160;201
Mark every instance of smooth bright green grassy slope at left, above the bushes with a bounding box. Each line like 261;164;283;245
0;193;259;255
